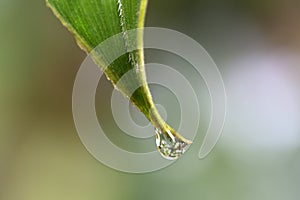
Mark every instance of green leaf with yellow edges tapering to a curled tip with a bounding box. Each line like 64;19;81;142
46;0;190;157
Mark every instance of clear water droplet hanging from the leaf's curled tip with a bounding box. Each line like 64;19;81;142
155;128;192;160
